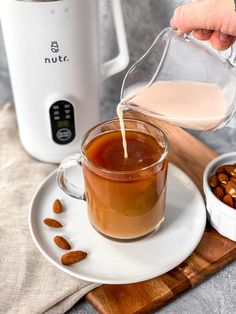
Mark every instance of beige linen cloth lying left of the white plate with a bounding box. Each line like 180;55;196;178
0;104;98;314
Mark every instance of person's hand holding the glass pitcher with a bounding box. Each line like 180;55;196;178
170;0;236;50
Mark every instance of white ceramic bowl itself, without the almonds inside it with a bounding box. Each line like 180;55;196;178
203;152;236;241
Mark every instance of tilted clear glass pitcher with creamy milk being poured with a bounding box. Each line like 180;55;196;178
121;28;236;131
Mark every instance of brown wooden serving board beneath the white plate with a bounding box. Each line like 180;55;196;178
86;113;236;314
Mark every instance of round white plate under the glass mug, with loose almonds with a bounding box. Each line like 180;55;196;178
29;165;206;284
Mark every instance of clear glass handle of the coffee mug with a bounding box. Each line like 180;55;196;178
57;154;86;201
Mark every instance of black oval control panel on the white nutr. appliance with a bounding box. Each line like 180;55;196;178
49;100;75;145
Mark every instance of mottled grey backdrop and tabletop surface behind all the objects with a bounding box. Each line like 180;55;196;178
0;0;236;314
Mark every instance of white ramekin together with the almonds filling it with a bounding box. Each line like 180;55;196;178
203;152;236;241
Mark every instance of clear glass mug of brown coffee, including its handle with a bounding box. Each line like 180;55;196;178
57;119;169;240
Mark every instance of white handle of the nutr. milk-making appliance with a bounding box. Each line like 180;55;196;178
101;0;129;80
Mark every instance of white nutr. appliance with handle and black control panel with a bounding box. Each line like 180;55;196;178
0;0;129;163
